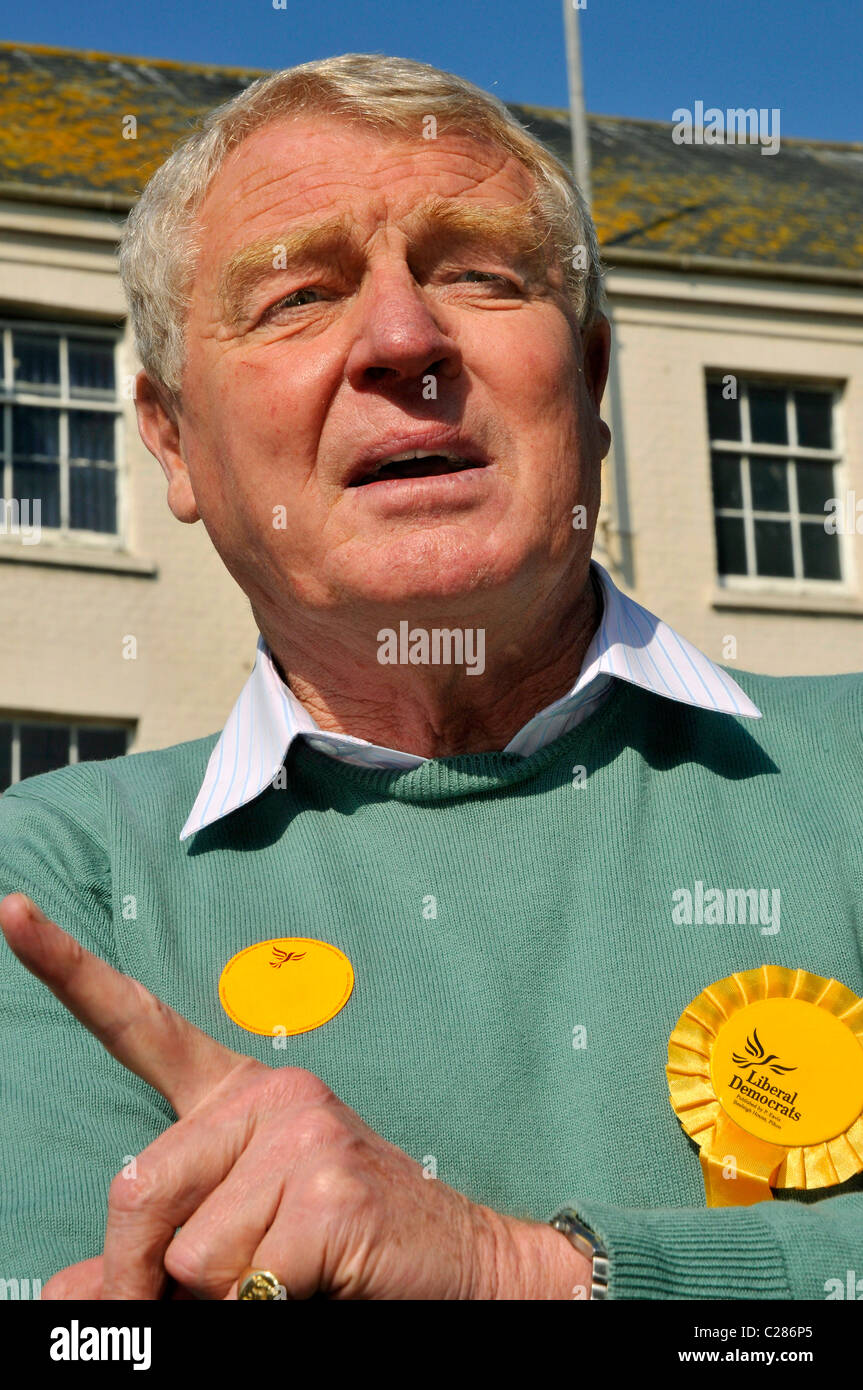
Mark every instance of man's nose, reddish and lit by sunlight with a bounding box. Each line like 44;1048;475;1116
345;261;461;391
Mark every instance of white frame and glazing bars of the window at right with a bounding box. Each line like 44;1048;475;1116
702;366;857;599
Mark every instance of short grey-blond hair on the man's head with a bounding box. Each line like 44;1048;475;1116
120;53;603;402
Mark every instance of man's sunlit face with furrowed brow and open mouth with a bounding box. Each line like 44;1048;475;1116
172;117;609;617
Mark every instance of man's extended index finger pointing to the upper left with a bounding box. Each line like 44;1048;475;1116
0;892;249;1116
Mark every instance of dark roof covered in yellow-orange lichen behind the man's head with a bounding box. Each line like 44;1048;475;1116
0;42;863;270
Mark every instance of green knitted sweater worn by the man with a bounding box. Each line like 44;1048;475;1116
0;671;863;1298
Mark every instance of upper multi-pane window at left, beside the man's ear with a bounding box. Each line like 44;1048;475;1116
0;322;120;541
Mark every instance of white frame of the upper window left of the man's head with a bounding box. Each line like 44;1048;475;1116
0;313;128;552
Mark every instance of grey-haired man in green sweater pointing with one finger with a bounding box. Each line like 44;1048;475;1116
0;54;863;1300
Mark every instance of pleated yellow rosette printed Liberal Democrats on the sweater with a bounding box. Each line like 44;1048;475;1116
666;965;863;1207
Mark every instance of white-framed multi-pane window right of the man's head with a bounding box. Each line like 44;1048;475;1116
707;375;842;581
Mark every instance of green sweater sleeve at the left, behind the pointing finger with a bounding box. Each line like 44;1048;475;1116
0;765;174;1287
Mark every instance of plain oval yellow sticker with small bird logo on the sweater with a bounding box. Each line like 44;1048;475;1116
218;937;353;1037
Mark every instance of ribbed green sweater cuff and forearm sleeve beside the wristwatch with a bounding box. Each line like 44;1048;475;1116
553;1191;863;1300
